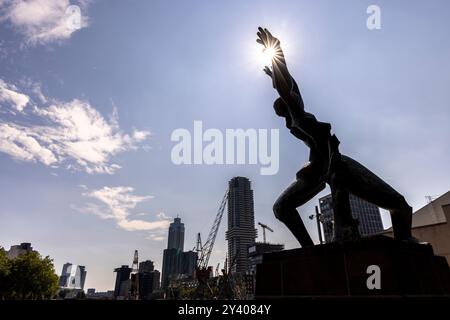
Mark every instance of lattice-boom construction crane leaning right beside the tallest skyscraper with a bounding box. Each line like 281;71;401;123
194;190;228;300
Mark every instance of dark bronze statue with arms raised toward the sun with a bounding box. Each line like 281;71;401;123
256;27;416;247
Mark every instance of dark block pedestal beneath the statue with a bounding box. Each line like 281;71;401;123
255;236;450;299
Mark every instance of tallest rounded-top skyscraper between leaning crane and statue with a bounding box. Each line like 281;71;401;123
225;177;256;273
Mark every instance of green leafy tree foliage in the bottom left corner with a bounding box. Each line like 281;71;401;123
0;249;58;299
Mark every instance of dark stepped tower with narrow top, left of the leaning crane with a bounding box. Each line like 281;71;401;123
161;217;197;288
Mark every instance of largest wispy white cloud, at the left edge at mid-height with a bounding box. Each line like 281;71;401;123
0;80;150;174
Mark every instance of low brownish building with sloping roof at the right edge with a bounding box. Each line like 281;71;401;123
384;191;450;264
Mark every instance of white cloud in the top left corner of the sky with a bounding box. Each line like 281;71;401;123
0;0;88;45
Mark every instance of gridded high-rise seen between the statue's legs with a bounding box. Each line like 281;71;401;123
319;194;384;243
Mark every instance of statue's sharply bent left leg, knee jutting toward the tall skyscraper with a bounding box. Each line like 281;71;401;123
273;166;325;247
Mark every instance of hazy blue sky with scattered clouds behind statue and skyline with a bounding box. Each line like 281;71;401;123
0;0;450;290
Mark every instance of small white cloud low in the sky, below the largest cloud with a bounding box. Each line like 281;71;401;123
81;186;170;235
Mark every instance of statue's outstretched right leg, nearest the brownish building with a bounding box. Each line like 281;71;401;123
342;155;412;240
